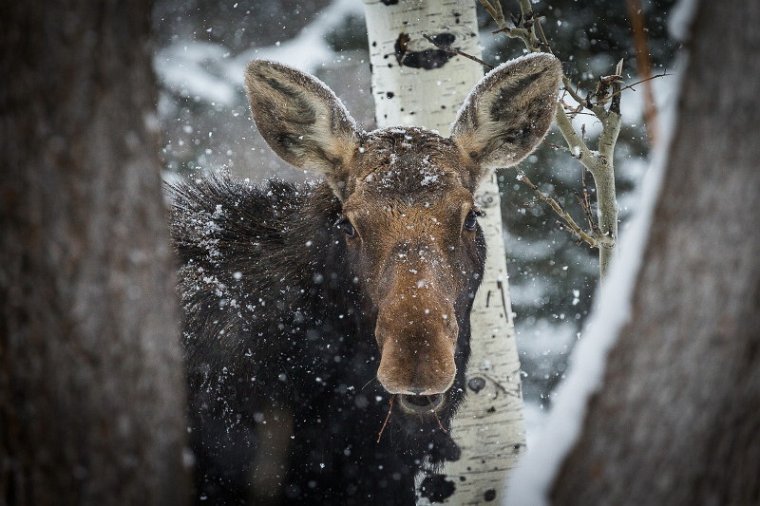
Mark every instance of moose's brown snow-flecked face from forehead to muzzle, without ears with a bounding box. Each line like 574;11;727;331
341;129;485;406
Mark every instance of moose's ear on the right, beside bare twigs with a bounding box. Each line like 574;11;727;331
451;53;562;183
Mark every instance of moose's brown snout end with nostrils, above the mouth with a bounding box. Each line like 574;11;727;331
375;304;458;395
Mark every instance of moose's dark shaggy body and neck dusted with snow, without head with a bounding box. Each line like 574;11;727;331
171;176;476;504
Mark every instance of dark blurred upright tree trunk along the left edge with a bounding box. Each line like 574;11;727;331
0;0;188;506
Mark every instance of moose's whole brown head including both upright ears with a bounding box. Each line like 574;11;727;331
246;54;561;412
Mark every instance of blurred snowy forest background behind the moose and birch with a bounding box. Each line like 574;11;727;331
154;0;678;440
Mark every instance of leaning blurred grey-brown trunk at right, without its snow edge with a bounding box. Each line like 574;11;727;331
551;0;760;505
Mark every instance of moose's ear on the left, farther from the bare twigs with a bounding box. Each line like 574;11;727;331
245;60;358;193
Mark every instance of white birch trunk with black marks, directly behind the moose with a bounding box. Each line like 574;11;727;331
365;0;525;504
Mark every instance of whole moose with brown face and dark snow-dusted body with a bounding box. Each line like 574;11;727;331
169;54;561;505
